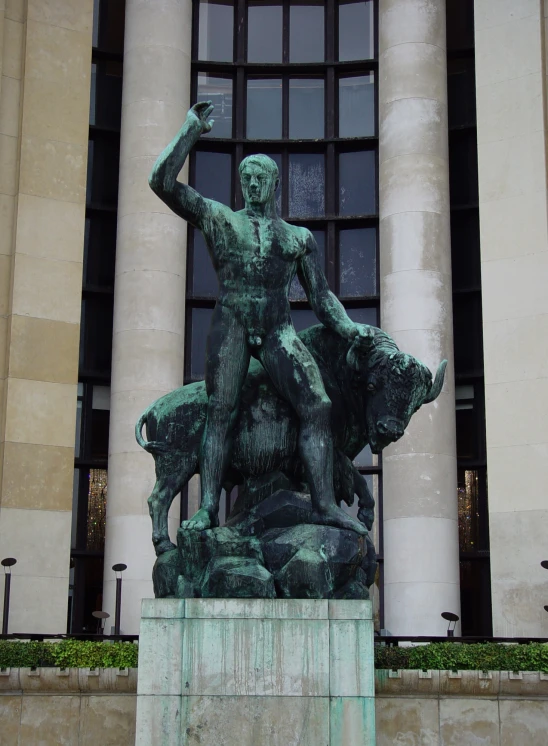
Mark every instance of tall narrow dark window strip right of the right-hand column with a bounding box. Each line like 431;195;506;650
447;0;492;635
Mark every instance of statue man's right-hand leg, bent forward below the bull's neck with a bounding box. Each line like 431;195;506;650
260;326;367;534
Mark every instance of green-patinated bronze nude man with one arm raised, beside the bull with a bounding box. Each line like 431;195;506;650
149;101;367;534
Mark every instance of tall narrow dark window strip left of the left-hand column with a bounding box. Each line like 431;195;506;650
68;0;125;632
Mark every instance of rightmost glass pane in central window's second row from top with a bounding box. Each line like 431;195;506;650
339;73;375;137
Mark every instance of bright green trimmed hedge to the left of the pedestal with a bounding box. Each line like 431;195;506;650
0;639;139;668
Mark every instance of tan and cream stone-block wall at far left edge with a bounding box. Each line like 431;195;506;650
0;0;93;632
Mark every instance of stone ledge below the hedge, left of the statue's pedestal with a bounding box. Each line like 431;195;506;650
0;667;137;695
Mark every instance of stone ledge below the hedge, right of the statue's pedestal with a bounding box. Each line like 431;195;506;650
375;669;548;699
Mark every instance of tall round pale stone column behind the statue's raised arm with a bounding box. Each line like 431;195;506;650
103;0;192;634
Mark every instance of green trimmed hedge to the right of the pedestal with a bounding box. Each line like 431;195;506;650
375;642;548;673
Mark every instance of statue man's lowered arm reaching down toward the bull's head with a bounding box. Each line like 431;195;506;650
297;231;368;340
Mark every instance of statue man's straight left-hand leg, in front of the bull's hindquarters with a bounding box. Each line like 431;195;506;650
182;304;250;530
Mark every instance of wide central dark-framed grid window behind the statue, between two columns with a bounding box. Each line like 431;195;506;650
182;0;382;620
